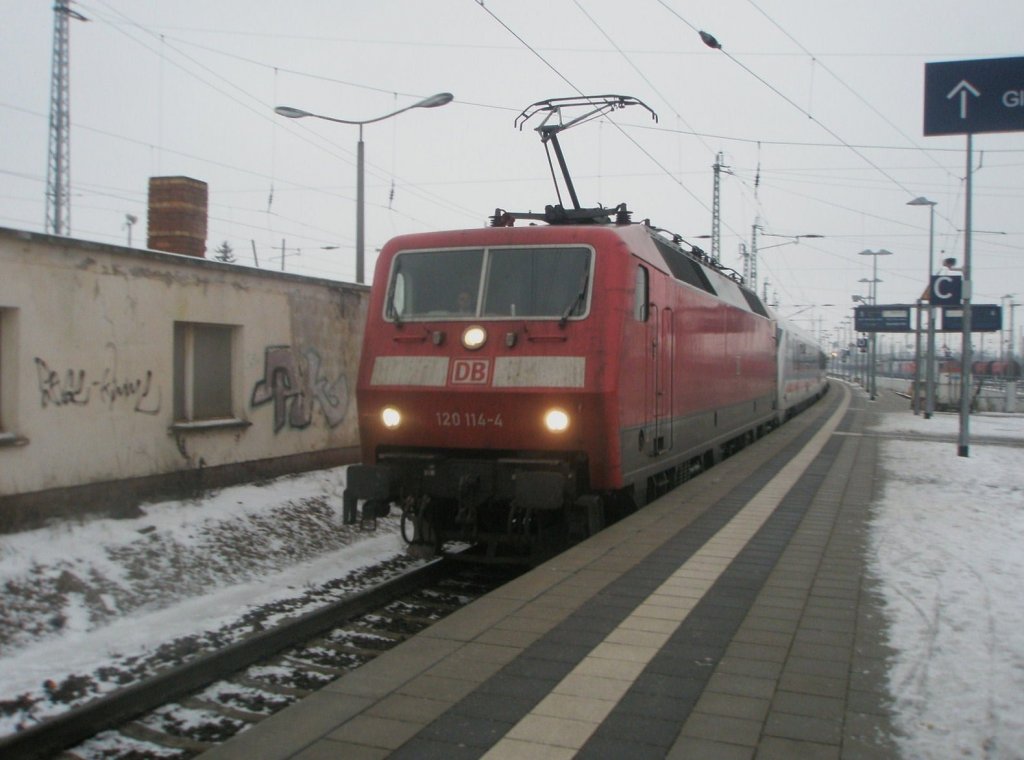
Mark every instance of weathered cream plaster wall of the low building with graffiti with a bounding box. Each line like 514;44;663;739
0;228;368;506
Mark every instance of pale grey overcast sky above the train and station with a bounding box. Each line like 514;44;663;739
0;0;1024;349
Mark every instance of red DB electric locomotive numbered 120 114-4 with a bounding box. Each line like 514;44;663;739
345;96;823;553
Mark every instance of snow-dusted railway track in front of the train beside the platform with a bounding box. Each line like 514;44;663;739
0;558;518;760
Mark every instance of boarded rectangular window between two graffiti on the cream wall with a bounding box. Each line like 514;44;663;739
174;322;236;422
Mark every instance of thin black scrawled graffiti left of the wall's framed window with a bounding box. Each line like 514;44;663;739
36;343;162;415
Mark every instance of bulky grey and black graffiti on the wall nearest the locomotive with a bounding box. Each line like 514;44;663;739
252;346;348;432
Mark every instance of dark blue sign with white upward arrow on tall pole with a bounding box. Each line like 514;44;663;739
925;57;1024;135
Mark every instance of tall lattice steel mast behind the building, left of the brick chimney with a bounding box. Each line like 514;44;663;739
46;0;88;235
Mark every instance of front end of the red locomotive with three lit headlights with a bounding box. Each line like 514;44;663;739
346;226;627;557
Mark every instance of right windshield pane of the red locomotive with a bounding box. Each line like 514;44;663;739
483;248;590;319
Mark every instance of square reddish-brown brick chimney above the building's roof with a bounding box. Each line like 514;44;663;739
146;177;207;257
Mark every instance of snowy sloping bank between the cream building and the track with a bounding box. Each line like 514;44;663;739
0;467;409;735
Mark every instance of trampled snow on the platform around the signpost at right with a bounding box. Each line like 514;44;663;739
870;412;1024;760
